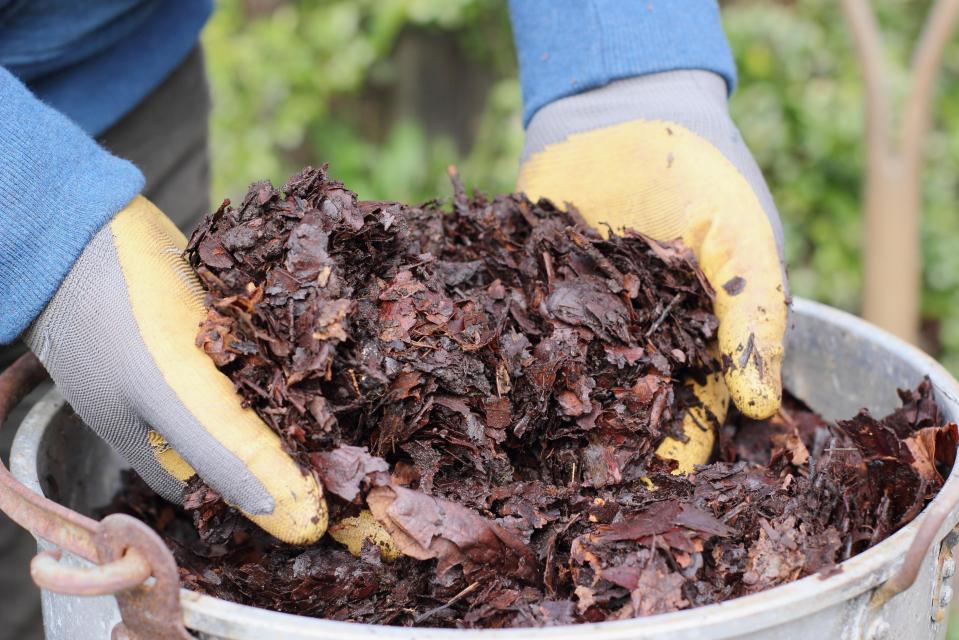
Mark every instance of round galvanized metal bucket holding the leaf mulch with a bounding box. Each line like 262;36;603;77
0;299;959;640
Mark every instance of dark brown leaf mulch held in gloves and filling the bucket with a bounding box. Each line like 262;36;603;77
107;168;957;627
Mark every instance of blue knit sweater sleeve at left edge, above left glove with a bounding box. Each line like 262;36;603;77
0;67;143;344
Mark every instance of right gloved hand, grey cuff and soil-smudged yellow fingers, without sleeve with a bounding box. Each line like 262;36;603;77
518;71;787;470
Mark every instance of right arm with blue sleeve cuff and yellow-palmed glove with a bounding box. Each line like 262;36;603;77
510;0;788;418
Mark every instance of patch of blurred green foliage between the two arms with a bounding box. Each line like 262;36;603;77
203;0;522;201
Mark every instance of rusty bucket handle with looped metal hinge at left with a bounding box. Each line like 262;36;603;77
0;353;191;640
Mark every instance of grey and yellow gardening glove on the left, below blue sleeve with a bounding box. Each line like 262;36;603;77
25;197;327;543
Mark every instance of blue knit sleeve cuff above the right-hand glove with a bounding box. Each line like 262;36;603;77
509;0;736;124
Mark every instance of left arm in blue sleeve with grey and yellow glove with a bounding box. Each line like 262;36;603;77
0;68;327;543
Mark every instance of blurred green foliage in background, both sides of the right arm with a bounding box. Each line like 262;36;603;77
204;0;959;372
